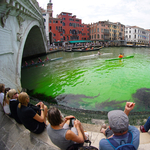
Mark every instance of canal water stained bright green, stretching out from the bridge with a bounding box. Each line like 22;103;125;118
21;47;150;111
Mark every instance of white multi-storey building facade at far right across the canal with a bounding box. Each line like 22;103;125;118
125;26;149;45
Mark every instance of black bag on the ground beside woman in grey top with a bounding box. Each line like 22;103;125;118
66;140;98;150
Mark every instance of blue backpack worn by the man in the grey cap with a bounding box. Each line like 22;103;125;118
107;131;136;150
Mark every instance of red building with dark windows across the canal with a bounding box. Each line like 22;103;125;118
49;12;90;42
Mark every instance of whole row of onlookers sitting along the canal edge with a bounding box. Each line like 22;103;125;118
0;83;150;150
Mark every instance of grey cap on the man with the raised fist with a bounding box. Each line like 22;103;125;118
108;110;129;133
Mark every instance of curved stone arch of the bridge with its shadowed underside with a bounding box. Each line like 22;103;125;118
16;21;47;88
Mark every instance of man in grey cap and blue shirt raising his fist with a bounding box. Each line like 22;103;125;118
99;102;140;150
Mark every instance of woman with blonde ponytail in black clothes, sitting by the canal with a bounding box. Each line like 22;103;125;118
17;92;47;134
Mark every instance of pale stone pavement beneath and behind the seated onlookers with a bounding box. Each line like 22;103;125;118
0;104;150;150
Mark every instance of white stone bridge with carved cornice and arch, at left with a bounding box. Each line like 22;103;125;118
0;0;47;91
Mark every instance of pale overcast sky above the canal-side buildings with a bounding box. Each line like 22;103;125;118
37;0;150;29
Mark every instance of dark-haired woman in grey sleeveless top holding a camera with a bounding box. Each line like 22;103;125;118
47;107;88;150
